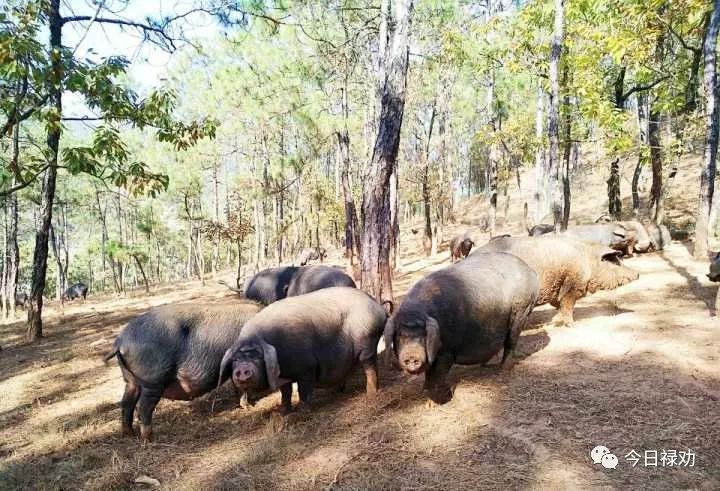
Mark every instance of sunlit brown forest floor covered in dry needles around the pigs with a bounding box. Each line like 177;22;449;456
0;153;720;490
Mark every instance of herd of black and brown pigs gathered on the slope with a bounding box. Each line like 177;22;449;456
106;217;720;441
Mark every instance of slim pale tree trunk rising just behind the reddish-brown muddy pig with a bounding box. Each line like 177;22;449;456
546;0;565;230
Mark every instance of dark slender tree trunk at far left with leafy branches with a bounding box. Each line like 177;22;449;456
26;0;63;341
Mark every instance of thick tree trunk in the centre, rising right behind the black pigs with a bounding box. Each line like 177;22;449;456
361;0;413;301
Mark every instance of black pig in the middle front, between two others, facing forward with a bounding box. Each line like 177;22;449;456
219;287;387;412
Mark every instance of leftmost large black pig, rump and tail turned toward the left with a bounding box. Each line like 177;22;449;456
106;302;261;441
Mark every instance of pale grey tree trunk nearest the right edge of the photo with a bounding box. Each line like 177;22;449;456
693;0;720;259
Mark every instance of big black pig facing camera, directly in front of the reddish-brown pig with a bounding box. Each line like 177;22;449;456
385;253;538;404
